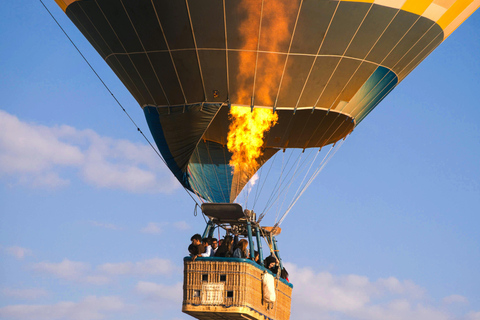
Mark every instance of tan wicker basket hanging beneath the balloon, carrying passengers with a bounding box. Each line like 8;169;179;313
182;257;293;320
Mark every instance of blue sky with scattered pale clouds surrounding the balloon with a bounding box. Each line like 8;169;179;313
0;0;480;320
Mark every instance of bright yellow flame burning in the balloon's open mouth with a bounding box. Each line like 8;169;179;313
227;106;278;174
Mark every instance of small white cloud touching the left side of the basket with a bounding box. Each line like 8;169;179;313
135;281;183;305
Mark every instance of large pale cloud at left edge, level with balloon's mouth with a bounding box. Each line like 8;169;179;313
0;110;179;193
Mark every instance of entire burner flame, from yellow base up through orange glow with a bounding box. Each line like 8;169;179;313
227;0;299;201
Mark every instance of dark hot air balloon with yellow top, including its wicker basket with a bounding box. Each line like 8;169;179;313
56;0;480;319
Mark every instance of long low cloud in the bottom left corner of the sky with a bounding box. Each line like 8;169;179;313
0;296;125;320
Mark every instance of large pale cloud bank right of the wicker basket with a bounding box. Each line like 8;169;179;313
286;263;477;320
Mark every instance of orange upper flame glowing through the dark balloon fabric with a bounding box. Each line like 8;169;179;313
236;0;298;106
